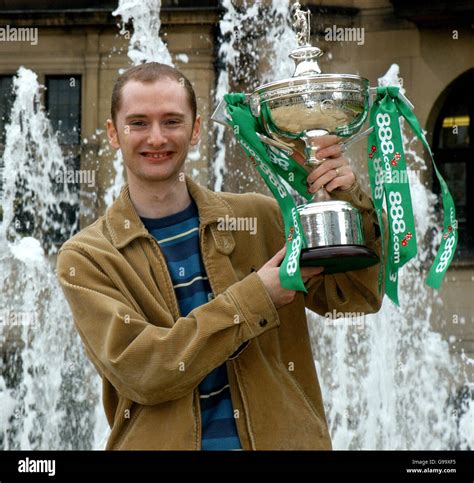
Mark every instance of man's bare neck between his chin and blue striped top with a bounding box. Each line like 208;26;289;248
128;176;191;218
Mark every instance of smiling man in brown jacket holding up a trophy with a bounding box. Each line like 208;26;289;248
58;63;381;450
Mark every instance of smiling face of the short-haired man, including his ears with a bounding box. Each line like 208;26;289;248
107;78;201;183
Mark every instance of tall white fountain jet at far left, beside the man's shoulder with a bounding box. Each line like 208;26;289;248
0;67;103;449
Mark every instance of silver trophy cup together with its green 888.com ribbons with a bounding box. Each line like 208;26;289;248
212;2;458;298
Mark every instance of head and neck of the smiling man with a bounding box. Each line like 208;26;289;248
107;70;201;218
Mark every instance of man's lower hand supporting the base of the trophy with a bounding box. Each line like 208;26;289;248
257;247;324;309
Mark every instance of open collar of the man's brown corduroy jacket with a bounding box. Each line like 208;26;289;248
105;176;235;255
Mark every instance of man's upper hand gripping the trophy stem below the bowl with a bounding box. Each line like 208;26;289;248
307;135;355;193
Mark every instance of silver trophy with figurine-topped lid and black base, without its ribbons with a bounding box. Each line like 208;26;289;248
212;2;379;273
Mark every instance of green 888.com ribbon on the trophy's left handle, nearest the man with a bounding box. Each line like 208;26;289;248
224;93;311;293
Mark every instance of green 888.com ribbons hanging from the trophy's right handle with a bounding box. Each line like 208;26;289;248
368;87;458;305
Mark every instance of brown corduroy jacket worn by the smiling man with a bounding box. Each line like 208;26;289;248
57;178;382;450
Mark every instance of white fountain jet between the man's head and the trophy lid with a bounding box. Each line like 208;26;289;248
212;0;297;191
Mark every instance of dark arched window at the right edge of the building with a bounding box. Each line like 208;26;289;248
433;69;474;261
